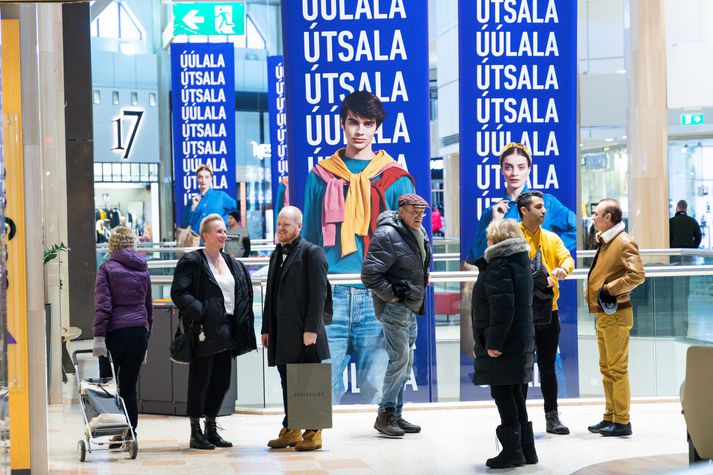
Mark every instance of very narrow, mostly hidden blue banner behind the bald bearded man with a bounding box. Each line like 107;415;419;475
267;56;289;222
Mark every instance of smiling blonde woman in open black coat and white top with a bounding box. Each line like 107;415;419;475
171;214;257;450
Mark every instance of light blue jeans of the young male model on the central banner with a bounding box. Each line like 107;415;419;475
327;285;388;404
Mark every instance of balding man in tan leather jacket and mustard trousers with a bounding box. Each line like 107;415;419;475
587;198;645;437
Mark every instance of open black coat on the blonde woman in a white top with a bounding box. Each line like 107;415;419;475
171;249;257;359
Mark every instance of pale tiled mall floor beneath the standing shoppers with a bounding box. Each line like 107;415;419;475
49;402;713;475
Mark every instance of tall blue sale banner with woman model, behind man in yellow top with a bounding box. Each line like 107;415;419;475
458;0;579;399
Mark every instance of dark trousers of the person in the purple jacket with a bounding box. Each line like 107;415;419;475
99;327;149;430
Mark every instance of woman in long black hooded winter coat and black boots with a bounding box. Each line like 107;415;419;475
472;219;537;468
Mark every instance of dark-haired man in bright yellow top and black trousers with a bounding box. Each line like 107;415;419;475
517;190;574;435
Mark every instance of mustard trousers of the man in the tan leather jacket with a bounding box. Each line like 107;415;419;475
596;307;634;424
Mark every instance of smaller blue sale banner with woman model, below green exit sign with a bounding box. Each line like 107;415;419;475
171;43;236;231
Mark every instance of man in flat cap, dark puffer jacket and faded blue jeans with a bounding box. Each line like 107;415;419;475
361;193;431;437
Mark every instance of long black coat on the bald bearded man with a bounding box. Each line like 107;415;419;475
261;237;332;366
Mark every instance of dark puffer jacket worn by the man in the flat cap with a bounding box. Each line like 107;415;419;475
361;211;431;318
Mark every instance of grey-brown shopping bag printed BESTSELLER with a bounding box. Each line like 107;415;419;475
287;363;332;429
